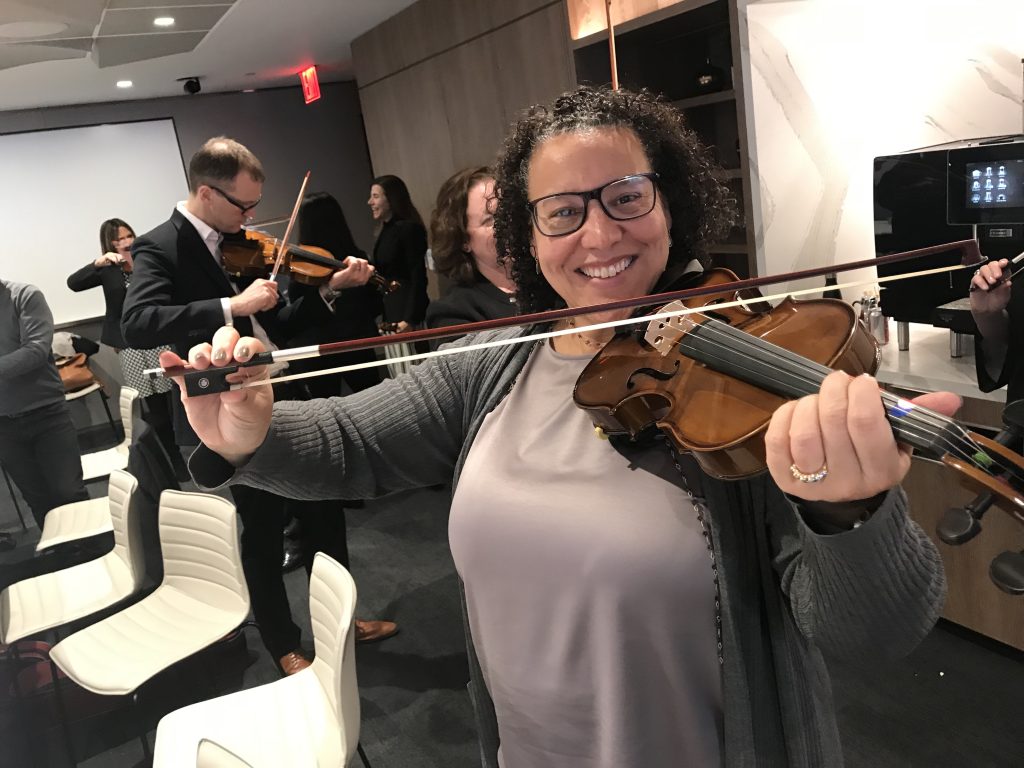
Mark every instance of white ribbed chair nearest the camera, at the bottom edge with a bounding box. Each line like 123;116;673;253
153;552;369;768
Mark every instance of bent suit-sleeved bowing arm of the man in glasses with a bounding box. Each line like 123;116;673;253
121;239;224;349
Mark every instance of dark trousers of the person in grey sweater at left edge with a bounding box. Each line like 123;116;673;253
0;400;89;530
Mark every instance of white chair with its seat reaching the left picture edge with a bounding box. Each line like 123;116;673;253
0;470;145;643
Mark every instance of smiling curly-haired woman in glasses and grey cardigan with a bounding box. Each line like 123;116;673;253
162;93;957;768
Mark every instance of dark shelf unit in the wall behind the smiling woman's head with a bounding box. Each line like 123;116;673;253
570;0;757;278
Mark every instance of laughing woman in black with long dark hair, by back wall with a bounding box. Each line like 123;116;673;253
367;175;430;333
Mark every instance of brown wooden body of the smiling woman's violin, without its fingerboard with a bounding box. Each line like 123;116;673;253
573;269;881;479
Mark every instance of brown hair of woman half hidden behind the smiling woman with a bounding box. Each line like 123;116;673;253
430;166;495;286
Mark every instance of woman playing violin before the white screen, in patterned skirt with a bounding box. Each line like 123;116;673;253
68;219;182;477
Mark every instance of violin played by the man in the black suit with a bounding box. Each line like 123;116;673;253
220;229;401;294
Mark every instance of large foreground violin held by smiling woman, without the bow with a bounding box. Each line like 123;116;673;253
572;268;1024;522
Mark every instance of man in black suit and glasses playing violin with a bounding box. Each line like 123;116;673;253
122;136;373;674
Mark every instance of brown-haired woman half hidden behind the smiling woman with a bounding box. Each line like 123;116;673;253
427;166;516;328
